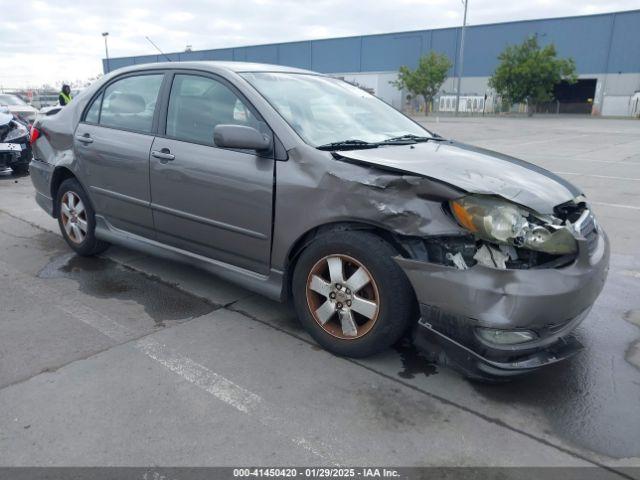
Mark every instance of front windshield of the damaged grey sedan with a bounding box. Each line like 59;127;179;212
243;72;430;147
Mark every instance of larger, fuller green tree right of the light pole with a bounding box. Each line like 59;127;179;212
489;35;578;115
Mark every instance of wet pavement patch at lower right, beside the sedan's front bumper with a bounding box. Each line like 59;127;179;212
471;316;640;458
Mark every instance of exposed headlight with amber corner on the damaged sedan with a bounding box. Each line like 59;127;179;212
449;195;578;255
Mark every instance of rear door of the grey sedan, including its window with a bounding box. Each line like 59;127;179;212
74;71;164;238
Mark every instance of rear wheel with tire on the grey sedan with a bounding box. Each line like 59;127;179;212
56;178;109;257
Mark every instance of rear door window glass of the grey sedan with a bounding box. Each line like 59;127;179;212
99;74;163;133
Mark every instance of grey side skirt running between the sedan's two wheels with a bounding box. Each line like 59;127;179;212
96;215;284;302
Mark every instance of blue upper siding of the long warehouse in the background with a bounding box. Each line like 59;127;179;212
103;10;640;76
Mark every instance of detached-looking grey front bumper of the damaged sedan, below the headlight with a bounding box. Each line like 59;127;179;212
396;229;609;377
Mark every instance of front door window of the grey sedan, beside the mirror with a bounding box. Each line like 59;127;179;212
167;75;259;145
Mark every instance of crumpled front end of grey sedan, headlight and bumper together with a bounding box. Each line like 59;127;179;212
396;195;609;378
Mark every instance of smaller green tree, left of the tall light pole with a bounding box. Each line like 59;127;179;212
390;51;451;115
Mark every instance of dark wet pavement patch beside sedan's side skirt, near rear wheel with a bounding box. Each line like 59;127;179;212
38;254;217;326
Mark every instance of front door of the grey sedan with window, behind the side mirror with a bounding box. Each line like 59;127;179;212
150;72;274;273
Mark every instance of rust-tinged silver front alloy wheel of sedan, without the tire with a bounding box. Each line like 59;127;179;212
306;254;380;340
